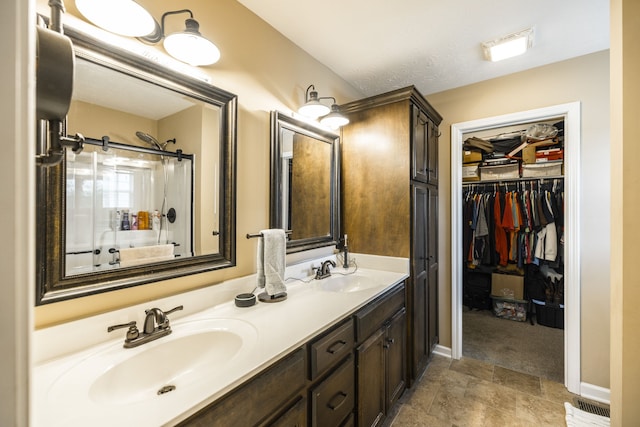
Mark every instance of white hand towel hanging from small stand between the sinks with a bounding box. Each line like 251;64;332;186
256;229;287;296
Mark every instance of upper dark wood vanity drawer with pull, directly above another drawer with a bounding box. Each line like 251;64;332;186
309;320;355;380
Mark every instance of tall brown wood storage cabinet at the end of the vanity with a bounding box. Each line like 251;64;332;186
341;86;442;382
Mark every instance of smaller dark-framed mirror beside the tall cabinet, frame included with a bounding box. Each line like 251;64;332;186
270;111;340;253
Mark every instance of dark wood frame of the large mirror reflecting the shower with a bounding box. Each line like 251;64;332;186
36;24;237;305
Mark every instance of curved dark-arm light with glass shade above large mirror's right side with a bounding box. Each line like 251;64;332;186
138;9;220;66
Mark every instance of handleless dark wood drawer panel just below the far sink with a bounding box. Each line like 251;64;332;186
355;282;405;342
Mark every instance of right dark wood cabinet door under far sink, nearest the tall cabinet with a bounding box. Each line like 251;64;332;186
384;309;407;413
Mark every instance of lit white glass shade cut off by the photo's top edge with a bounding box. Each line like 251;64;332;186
76;0;156;37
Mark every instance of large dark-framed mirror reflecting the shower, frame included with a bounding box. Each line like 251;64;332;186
36;22;237;304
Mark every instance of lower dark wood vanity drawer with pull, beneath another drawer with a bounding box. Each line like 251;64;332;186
311;356;355;427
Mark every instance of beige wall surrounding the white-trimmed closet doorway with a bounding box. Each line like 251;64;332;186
427;51;610;388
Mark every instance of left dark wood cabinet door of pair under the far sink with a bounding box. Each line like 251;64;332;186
356;329;385;427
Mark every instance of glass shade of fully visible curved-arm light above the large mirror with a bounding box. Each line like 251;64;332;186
163;32;220;66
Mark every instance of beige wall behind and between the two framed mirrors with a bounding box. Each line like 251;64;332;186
35;0;362;328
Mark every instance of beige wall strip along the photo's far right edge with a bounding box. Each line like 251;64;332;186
610;0;640;427
